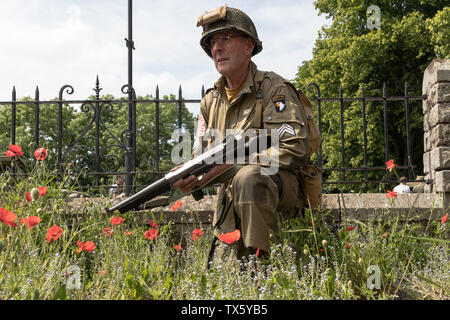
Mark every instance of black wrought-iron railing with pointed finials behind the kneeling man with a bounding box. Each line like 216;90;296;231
0;77;426;192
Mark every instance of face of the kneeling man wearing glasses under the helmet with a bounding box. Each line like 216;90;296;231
209;31;254;77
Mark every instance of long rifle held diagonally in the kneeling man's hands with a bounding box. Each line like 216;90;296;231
106;134;271;213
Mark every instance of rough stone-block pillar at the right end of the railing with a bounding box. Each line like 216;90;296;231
422;59;450;208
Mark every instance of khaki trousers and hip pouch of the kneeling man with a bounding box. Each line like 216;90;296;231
213;165;304;258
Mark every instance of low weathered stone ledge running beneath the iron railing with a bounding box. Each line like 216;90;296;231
69;193;449;226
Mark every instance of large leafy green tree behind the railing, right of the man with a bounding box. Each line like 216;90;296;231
295;0;450;192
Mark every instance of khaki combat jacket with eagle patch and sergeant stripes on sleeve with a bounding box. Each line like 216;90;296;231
194;61;308;169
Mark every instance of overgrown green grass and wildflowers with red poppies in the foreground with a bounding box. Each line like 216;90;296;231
0;160;450;300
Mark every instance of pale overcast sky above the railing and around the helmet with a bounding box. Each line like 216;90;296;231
0;0;329;114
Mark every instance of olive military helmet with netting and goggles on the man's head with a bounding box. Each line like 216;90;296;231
197;5;262;58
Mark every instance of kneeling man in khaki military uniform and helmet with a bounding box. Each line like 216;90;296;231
174;6;308;258
